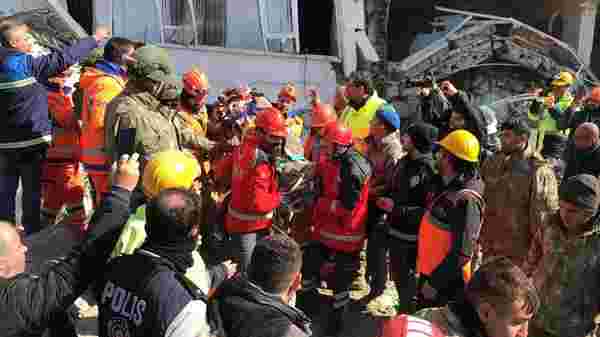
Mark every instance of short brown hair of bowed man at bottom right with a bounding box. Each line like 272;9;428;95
465;257;540;314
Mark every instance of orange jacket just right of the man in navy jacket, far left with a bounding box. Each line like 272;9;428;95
48;90;80;162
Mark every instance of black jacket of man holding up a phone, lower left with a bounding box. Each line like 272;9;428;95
0;187;131;337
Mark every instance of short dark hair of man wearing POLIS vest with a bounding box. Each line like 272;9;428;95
146;188;202;242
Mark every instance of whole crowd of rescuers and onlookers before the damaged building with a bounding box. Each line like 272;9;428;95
0;20;600;337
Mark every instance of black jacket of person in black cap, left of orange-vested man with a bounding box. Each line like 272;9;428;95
386;153;435;243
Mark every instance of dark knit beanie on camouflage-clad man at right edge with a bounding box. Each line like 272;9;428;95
559;174;599;211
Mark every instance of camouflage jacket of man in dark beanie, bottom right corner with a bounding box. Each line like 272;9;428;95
525;214;600;337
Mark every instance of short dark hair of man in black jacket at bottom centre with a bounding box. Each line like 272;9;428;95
248;234;302;294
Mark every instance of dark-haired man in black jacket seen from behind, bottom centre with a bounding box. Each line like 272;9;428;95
209;235;312;337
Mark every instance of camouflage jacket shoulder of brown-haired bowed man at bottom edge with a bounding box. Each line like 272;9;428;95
415;303;487;337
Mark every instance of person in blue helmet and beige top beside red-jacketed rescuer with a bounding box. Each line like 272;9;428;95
367;104;404;298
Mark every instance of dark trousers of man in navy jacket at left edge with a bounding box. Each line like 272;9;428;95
0;144;48;235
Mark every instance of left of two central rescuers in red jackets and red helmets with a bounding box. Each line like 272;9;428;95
222;108;287;273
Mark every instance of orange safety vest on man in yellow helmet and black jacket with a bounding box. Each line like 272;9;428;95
417;189;483;283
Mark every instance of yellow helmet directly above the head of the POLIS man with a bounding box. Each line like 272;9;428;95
142;150;201;198
